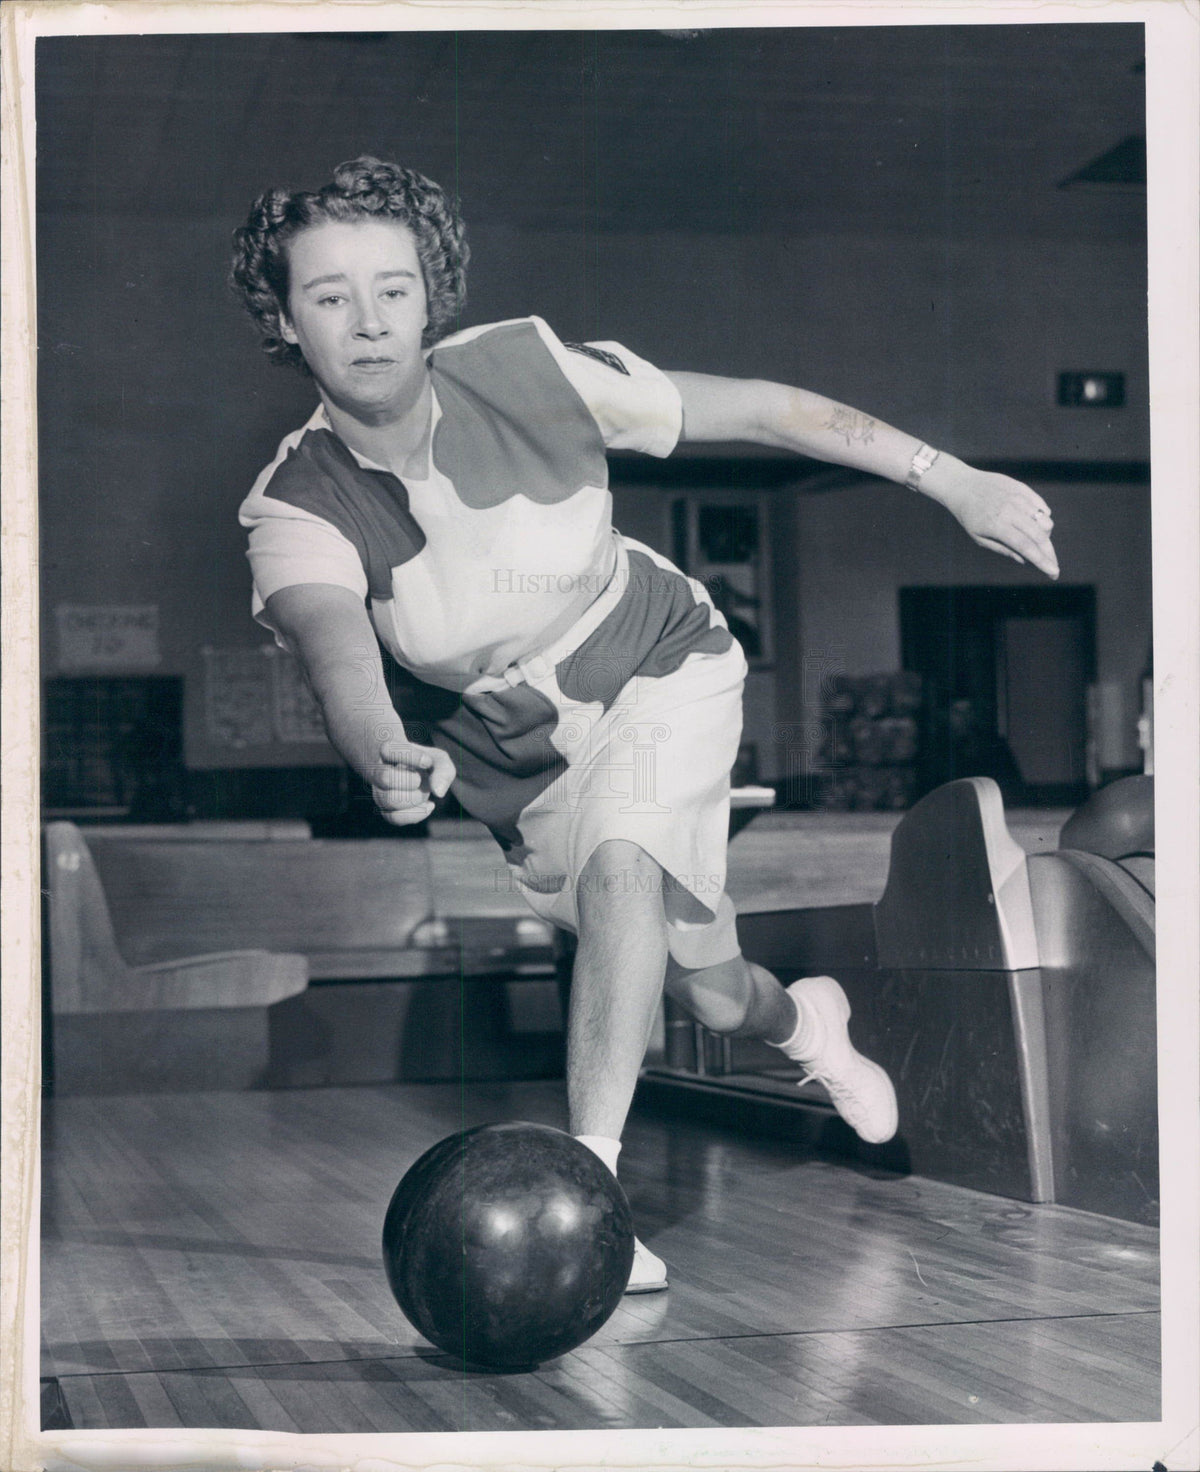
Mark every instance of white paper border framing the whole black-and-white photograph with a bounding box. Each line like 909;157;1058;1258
0;0;1200;1472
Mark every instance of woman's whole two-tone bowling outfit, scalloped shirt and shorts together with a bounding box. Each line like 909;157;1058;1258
240;318;745;964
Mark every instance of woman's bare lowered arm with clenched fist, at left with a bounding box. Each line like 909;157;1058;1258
267;583;455;827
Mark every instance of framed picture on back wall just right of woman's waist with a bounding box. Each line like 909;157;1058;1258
670;490;774;670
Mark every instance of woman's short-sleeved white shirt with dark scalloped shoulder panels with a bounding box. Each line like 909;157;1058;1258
240;316;682;689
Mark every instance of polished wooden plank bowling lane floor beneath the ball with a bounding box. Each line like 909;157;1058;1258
43;1083;1159;1432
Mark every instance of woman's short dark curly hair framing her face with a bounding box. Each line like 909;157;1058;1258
230;155;470;372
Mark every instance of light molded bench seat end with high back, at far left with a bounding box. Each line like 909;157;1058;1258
43;823;308;1094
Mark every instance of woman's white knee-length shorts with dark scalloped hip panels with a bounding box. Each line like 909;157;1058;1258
433;537;747;967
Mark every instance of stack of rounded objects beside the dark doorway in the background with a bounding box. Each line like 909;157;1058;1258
813;670;922;813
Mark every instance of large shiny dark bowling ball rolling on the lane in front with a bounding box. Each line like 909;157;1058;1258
383;1123;633;1369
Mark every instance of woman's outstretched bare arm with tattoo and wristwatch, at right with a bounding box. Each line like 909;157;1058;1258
667;372;1059;577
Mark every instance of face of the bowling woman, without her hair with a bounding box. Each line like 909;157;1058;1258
281;219;428;422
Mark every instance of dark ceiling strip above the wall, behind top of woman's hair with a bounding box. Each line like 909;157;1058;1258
37;24;1146;237
